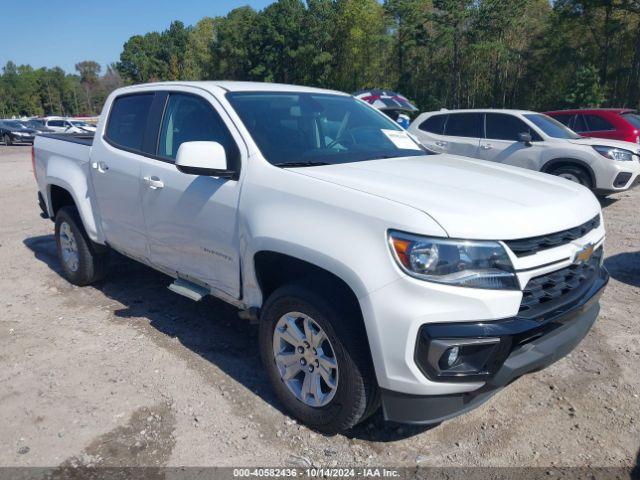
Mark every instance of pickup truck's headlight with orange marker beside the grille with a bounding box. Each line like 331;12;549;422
389;231;519;290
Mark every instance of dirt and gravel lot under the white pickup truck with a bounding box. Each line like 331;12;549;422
0;146;640;467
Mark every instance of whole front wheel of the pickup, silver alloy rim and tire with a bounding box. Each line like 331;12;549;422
260;285;379;433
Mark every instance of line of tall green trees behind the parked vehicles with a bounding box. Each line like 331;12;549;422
0;0;640;116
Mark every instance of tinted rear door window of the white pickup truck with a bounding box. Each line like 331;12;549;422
105;93;154;152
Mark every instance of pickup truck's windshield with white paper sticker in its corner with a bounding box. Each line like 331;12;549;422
222;92;427;166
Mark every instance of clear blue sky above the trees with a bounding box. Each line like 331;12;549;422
0;0;273;73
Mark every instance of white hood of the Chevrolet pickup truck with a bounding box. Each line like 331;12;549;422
295;154;600;240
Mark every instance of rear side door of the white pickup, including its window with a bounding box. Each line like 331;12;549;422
91;92;155;259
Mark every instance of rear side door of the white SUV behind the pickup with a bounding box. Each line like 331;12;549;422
443;112;483;158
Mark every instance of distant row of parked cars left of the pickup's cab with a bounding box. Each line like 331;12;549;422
0;117;96;145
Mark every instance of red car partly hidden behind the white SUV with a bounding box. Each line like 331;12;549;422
546;108;640;143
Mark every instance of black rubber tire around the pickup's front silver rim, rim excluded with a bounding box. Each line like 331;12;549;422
260;282;380;434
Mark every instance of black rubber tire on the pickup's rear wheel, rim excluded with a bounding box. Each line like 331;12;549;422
55;206;109;286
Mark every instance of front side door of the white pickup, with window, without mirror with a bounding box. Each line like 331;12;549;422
141;92;240;298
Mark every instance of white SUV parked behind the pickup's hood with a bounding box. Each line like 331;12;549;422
408;110;640;195
